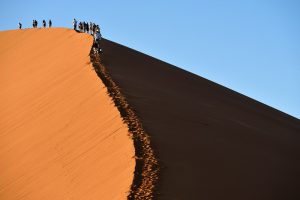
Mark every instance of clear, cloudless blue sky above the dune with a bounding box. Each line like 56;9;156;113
0;0;300;118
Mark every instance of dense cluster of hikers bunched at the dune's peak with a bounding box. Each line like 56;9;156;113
73;18;102;53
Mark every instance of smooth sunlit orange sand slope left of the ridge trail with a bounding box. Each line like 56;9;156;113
0;28;135;200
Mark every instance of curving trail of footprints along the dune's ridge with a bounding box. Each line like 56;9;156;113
90;49;159;200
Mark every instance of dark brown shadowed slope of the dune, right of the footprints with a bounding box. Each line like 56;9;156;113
102;40;300;200
